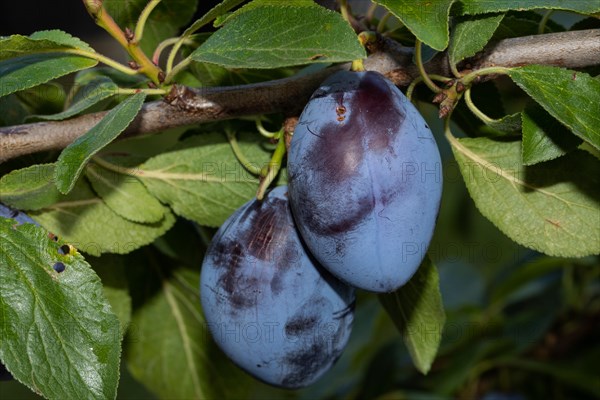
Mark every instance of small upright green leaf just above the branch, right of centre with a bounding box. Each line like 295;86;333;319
448;14;504;65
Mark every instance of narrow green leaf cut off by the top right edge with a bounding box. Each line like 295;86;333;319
459;0;600;14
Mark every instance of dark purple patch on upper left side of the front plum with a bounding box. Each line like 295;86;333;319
292;72;405;236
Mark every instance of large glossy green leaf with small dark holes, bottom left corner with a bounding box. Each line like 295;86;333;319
0;218;121;399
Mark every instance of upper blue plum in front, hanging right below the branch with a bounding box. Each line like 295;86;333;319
288;71;442;292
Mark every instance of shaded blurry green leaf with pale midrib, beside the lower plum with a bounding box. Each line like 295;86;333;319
125;267;250;399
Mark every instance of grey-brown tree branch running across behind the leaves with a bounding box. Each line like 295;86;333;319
0;29;600;162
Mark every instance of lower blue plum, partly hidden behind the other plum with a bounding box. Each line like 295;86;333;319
200;186;355;388
